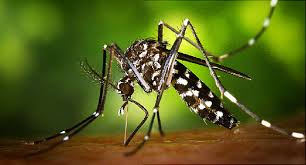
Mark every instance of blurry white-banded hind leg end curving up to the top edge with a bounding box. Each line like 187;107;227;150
214;0;278;62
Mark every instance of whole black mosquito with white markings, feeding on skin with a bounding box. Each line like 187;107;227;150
29;0;305;155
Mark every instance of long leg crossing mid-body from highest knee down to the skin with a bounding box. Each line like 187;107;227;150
126;19;189;155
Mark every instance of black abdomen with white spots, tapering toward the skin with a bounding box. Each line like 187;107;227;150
172;61;238;129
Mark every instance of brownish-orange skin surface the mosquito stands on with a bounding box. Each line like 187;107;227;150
0;114;305;164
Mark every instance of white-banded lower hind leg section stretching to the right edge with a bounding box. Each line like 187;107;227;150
224;91;305;141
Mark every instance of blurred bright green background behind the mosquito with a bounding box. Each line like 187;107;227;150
0;0;305;138
